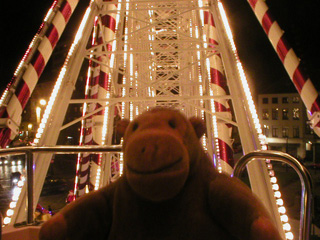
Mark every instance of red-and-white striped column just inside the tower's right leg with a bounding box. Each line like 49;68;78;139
204;7;234;173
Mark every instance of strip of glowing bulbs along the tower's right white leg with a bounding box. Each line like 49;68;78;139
218;0;293;240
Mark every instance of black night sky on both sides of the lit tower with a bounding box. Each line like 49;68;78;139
0;0;320;99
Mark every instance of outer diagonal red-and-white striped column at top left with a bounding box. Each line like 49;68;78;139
0;0;78;148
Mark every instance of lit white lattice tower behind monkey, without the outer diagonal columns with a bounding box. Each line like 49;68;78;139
3;0;292;237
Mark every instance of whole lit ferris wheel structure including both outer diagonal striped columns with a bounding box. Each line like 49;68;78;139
0;0;320;239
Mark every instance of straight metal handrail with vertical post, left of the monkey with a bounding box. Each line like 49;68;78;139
0;145;122;224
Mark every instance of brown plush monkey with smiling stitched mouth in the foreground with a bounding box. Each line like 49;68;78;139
40;108;281;240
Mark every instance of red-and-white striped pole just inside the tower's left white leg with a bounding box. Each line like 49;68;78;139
75;0;117;196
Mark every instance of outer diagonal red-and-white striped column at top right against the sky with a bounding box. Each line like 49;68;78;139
248;0;320;135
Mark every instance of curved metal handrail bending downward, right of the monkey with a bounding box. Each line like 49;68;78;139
233;150;312;240
